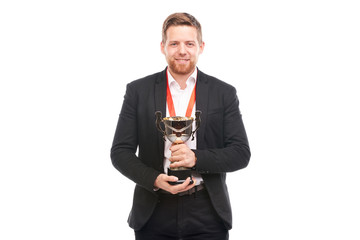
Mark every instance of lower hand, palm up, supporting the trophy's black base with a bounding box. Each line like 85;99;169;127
154;173;195;194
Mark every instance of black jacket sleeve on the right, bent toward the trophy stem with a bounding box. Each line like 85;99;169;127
193;87;251;174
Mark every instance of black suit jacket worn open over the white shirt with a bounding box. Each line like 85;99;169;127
111;69;250;230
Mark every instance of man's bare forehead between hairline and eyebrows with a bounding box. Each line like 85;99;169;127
166;25;197;41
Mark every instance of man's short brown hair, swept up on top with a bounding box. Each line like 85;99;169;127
162;13;202;44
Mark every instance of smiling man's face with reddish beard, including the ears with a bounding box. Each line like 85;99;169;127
161;26;204;75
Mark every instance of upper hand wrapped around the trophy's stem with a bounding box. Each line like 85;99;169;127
169;144;196;168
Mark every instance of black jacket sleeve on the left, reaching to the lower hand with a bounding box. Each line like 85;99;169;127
111;84;160;191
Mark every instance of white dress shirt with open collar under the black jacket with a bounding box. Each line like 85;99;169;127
164;68;203;185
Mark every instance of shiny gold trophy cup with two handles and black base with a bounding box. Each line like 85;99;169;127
155;111;201;185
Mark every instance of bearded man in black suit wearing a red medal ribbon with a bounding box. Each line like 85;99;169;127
111;13;250;240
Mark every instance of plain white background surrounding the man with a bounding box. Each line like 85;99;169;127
0;0;360;240
